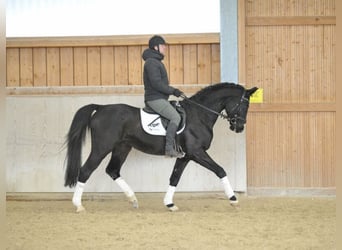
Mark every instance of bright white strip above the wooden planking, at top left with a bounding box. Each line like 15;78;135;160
6;0;220;37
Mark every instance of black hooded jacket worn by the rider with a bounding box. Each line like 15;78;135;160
142;48;175;102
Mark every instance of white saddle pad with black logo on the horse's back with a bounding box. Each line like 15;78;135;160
140;109;185;136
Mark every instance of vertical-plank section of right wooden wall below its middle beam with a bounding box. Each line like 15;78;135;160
247;112;335;187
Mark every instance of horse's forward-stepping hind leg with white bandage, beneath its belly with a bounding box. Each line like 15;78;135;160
106;144;138;208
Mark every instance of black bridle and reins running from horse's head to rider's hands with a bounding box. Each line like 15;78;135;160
180;90;249;125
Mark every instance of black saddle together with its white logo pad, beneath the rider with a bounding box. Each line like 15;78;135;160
140;101;186;136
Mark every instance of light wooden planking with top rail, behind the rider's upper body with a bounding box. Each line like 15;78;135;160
7;34;220;87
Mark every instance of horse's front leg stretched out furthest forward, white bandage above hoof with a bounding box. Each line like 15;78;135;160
193;151;238;205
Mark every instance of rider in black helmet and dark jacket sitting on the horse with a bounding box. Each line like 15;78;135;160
142;35;184;158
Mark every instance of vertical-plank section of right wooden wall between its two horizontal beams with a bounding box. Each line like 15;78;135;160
246;26;335;103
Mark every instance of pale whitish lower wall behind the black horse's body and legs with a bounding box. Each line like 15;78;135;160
6;96;242;192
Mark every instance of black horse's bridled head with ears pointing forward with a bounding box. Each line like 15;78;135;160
225;87;258;133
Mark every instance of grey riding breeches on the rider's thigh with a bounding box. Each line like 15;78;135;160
146;99;181;126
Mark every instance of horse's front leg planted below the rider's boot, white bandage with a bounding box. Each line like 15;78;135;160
164;157;189;212
